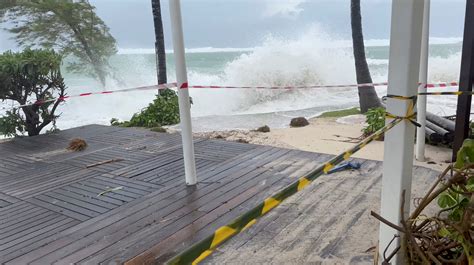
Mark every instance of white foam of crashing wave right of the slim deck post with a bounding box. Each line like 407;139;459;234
190;28;460;119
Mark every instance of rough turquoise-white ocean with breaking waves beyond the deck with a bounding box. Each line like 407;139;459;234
3;34;461;131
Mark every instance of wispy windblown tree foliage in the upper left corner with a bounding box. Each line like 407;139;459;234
0;0;117;86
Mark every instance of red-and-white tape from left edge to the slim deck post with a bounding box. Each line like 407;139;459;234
2;83;178;110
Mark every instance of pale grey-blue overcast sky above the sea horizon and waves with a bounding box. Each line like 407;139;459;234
0;0;465;50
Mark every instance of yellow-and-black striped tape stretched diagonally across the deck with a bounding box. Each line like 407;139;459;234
168;117;404;265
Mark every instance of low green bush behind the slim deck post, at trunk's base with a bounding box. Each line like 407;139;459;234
110;89;179;128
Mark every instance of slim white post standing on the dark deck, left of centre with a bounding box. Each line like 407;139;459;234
169;0;197;185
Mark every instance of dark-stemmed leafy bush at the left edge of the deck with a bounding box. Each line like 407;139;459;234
0;49;66;136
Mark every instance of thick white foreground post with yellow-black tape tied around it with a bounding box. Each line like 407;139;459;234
379;0;423;264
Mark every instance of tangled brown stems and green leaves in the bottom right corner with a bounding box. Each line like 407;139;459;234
371;161;474;264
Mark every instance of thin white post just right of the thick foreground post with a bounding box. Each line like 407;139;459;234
415;0;430;162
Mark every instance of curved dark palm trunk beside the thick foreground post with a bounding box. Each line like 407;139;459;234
351;0;382;113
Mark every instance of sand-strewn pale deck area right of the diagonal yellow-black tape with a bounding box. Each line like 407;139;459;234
203;161;439;265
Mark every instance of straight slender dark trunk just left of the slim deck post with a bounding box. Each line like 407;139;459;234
151;0;167;84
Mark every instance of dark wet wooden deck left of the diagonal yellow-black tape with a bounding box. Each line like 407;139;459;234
0;125;342;264
